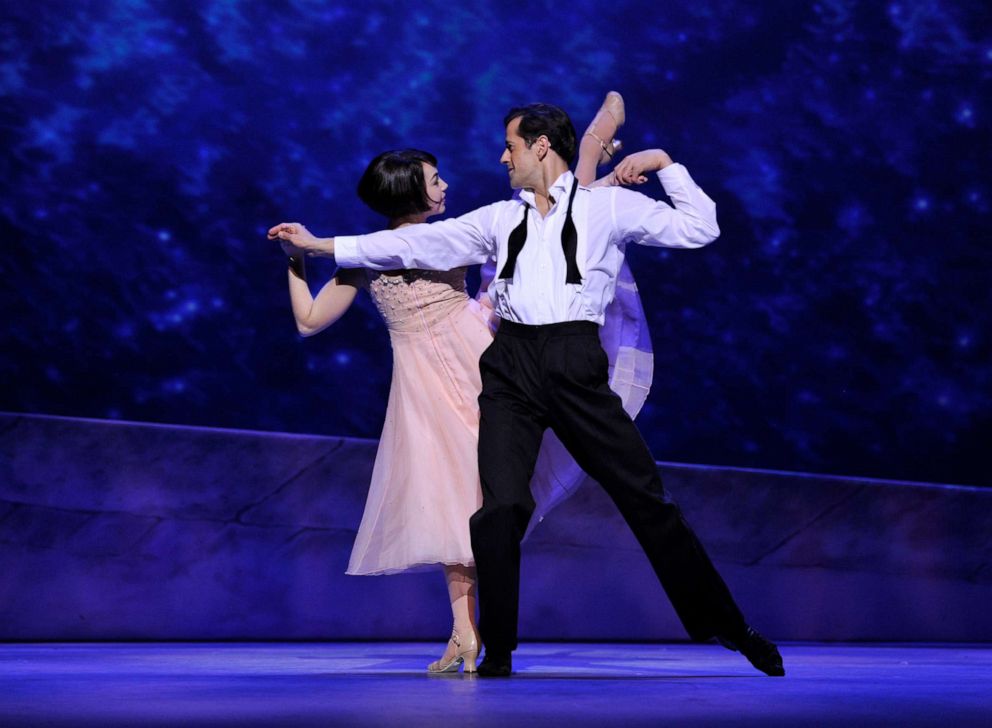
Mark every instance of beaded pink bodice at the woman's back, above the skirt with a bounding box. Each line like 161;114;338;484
366;268;468;332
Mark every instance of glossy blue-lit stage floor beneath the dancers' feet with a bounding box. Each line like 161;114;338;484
0;642;992;728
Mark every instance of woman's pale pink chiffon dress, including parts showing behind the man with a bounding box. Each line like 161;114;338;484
346;264;653;575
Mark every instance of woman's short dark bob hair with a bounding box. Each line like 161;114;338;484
358;149;437;220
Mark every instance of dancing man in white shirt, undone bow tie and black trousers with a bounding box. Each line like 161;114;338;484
270;104;785;677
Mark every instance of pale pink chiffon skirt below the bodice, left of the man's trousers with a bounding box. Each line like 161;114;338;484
347;299;492;574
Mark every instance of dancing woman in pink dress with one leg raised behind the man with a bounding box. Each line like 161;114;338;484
269;92;650;672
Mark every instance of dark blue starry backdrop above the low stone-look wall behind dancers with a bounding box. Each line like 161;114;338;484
0;5;992;485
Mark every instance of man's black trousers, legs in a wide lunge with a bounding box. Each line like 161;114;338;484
471;321;745;653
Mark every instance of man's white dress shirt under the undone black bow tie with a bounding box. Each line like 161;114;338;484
334;164;720;324
